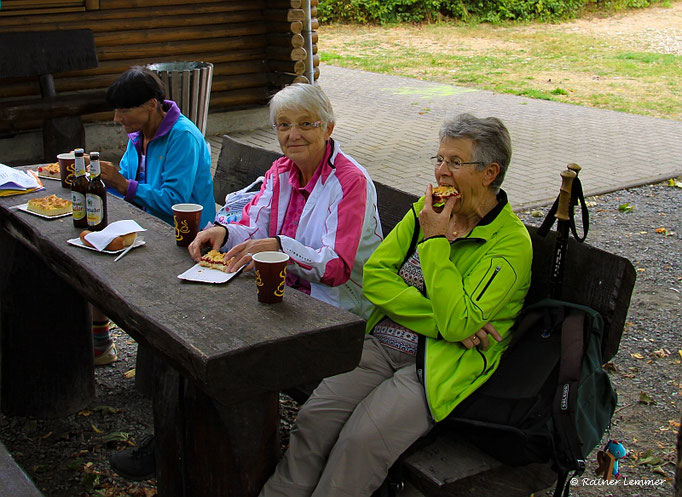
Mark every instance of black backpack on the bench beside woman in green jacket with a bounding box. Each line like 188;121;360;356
443;299;617;497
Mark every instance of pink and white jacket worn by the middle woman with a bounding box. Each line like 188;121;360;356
223;139;383;318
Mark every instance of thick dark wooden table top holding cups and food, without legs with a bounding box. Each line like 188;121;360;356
0;170;364;398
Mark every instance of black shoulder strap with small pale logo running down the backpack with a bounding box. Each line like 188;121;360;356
552;310;585;497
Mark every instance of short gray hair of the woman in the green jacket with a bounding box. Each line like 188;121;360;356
438;114;512;192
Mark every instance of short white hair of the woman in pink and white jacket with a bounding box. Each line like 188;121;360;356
270;83;335;128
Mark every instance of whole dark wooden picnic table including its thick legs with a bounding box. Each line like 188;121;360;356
0;168;364;497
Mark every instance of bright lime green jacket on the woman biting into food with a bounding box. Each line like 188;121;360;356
363;191;533;421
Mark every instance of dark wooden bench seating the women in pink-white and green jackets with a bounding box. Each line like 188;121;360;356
214;136;635;497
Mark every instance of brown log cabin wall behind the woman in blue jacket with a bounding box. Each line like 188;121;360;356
0;0;319;133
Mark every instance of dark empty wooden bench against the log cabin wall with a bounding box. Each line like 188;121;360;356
0;29;111;162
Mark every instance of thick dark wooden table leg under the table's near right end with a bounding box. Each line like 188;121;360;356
154;358;279;497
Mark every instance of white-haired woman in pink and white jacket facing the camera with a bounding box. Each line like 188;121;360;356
189;84;382;318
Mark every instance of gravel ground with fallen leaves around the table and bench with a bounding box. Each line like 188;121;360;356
0;179;682;497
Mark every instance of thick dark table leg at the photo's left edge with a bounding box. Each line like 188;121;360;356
0;232;95;418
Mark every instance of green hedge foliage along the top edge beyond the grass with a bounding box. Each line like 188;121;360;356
318;0;668;24
